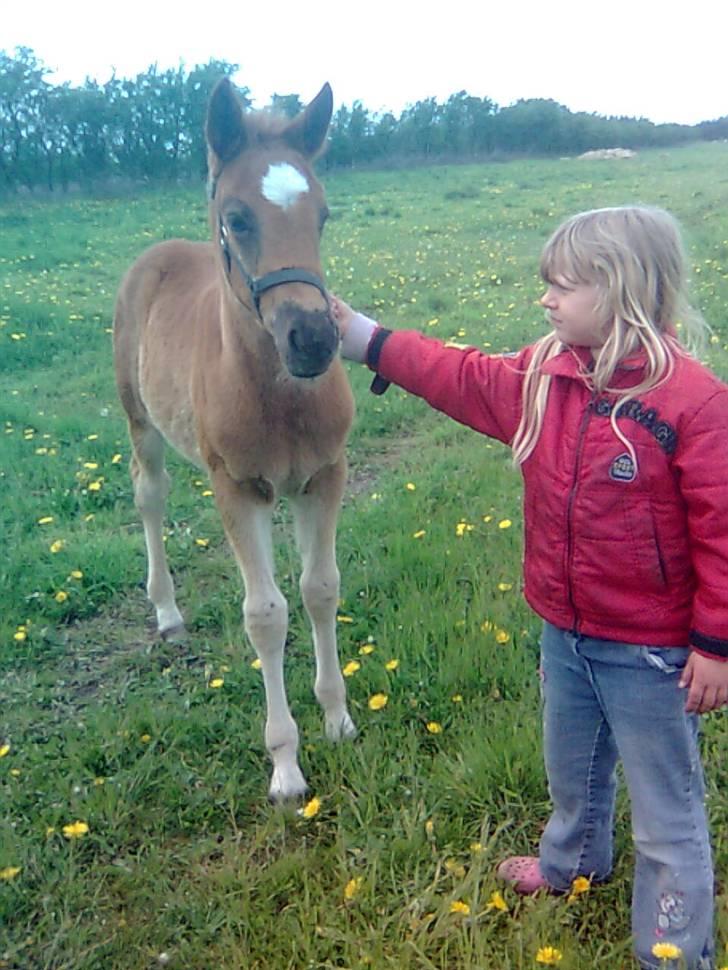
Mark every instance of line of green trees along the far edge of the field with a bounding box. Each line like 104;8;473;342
0;47;728;193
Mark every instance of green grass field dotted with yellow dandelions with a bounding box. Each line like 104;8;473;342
0;138;728;970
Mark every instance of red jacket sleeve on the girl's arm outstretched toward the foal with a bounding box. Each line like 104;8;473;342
368;330;531;444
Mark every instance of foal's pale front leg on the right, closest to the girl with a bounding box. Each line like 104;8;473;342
292;461;356;741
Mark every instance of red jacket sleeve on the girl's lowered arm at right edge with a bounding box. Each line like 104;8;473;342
675;385;728;660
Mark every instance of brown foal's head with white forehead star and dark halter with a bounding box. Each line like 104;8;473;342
205;78;339;378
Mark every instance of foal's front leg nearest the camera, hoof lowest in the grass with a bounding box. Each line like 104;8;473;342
211;470;306;801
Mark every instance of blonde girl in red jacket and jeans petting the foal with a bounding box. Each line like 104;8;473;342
333;207;728;970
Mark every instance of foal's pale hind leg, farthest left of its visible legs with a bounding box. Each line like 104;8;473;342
129;421;185;640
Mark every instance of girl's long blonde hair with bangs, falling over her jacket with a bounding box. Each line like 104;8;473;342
511;206;707;465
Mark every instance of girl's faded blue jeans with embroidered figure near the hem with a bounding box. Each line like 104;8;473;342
540;623;713;970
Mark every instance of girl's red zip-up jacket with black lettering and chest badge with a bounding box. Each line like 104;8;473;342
368;329;728;659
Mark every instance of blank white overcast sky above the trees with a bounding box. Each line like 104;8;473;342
5;0;728;124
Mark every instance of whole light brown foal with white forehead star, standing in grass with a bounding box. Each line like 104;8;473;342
114;80;355;800
